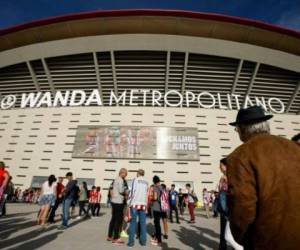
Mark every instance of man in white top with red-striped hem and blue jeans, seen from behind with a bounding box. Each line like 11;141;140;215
127;169;148;247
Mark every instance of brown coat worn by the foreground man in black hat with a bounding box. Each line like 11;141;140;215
227;134;300;250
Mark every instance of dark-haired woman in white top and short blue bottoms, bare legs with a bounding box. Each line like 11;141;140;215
37;175;57;226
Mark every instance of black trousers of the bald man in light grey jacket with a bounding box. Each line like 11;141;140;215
108;203;125;240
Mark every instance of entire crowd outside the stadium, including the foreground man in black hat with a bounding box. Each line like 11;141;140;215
0;106;300;250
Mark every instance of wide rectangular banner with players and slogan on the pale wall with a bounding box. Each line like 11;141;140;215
72;126;199;161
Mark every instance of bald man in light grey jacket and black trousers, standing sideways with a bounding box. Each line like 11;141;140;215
107;168;128;245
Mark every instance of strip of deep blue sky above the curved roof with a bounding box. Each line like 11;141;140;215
0;0;300;31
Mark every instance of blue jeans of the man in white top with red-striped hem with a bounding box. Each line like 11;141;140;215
128;208;146;246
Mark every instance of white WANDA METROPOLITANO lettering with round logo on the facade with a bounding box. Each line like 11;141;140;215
0;89;285;113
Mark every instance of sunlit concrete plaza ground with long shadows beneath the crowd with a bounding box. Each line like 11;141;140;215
0;204;219;250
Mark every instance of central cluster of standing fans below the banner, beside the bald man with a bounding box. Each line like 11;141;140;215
107;168;203;247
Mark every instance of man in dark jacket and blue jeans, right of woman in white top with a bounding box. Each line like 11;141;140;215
59;172;78;230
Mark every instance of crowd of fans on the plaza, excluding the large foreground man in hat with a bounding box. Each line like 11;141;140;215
3;163;220;246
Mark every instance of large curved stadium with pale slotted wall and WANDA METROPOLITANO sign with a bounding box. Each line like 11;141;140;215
0;10;300;195
